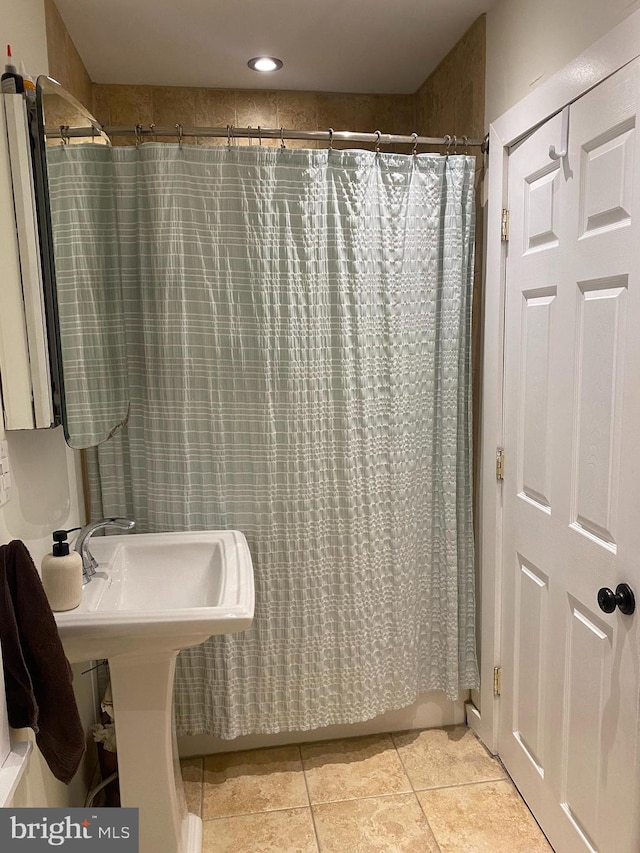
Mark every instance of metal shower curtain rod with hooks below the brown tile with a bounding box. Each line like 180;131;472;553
45;124;486;151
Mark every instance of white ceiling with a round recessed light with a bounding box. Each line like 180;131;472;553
56;0;493;94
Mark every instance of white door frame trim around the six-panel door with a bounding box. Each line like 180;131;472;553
467;10;640;754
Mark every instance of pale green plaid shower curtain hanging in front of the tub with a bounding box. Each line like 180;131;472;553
52;144;478;738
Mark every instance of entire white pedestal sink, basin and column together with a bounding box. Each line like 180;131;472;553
55;530;254;853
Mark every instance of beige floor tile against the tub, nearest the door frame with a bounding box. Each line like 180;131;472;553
393;726;507;791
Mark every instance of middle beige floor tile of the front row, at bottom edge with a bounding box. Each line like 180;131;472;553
312;793;438;853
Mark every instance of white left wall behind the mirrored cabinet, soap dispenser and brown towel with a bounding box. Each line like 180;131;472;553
0;0;94;806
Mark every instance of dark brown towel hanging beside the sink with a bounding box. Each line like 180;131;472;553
0;540;86;784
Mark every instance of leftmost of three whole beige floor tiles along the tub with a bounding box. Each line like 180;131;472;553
202;746;309;820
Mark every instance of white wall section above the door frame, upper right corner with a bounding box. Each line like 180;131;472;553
486;0;640;127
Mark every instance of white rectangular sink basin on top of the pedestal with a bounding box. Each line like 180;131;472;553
55;530;254;663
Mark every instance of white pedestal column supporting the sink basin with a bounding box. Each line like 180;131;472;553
109;649;202;853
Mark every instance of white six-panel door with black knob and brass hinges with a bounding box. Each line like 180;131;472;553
499;60;640;853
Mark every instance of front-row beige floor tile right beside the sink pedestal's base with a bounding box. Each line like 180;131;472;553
202;808;318;853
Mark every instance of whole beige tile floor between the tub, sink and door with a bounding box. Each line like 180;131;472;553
182;726;553;853
